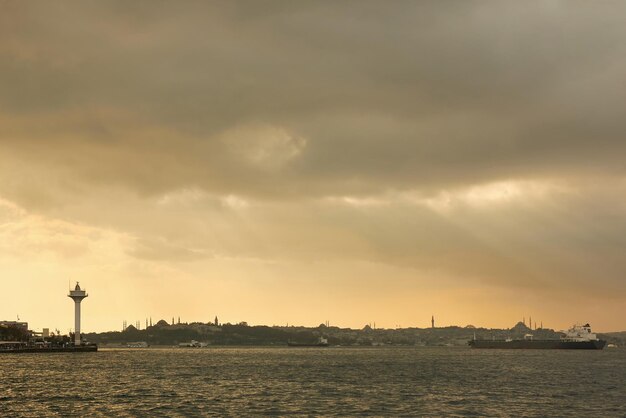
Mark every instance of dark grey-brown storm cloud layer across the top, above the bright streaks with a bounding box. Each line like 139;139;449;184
0;2;626;201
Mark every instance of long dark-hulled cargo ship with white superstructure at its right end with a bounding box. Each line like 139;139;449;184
468;324;606;350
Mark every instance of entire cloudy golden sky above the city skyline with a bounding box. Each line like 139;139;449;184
0;0;626;332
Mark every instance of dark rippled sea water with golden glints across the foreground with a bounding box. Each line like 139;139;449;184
0;347;626;417
